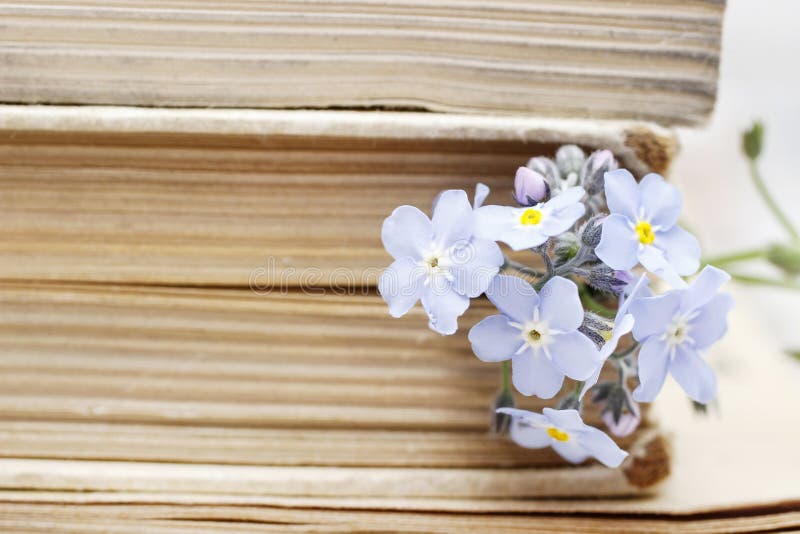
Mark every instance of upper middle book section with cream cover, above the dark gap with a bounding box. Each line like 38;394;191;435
0;106;676;289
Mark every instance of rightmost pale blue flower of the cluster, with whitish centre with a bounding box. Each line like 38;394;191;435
630;266;733;404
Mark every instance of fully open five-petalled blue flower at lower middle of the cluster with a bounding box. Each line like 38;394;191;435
469;275;600;399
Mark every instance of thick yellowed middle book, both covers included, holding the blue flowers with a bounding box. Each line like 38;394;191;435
0;107;675;498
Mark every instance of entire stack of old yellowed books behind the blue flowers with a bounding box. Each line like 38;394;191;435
0;0;792;532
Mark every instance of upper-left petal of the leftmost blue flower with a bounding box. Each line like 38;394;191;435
381;206;433;260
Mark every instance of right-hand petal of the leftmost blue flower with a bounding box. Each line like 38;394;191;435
450;238;504;298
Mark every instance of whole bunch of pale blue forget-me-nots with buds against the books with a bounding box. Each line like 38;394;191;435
379;145;733;467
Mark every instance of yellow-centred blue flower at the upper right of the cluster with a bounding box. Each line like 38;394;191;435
595;169;700;287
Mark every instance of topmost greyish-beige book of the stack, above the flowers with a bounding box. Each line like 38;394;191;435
0;0;724;124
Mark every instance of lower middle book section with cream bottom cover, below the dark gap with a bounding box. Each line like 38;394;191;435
0;283;670;498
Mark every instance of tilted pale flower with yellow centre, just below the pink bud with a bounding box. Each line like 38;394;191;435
475;187;586;250
